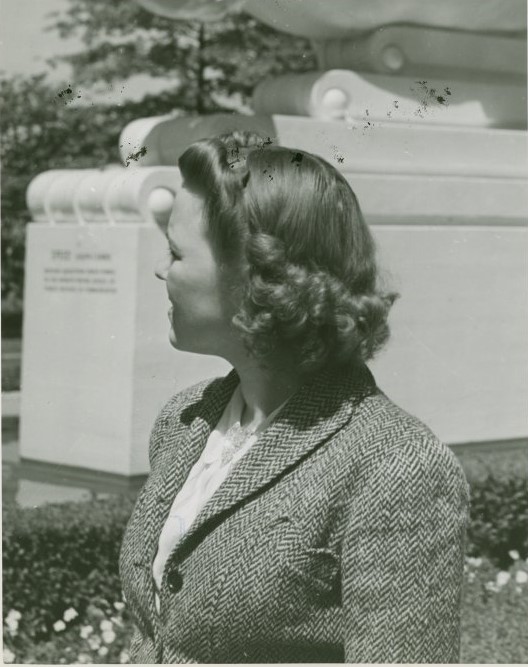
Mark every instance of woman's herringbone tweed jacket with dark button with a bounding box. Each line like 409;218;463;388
120;365;468;663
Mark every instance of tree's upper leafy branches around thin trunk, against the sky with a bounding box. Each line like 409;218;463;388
47;0;316;113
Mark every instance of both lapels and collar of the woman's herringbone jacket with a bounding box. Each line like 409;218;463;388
168;364;377;560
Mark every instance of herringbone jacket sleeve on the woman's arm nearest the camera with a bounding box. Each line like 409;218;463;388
342;436;469;663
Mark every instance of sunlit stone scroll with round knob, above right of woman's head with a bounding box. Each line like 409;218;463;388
253;70;526;128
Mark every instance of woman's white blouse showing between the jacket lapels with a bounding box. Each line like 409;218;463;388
152;385;287;613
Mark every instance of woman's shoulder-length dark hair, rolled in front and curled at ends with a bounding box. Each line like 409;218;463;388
179;132;396;372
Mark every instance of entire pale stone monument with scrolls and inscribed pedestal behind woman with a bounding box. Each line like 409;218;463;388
21;0;528;488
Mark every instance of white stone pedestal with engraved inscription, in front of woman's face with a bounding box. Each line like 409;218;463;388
20;168;229;479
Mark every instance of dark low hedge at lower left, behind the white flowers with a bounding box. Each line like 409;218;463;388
2;498;132;642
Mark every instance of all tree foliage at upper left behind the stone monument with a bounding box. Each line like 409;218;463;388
0;0;316;333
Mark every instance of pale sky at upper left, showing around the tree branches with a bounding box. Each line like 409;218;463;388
0;0;174;104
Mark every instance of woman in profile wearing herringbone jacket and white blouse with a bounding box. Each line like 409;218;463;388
121;133;468;663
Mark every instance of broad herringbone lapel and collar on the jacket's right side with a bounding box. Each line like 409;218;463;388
176;365;376;557
